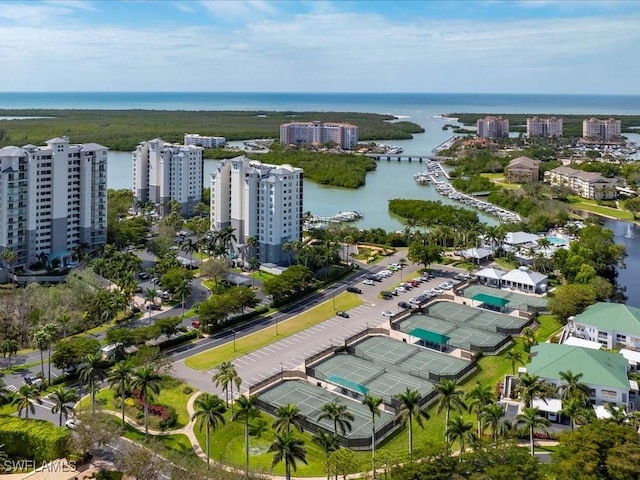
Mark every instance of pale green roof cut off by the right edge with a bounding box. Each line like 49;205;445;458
574;302;640;337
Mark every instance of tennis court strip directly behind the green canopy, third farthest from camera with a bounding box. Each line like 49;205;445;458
398;314;506;351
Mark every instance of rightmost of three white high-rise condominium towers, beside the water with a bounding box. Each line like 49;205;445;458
211;156;303;264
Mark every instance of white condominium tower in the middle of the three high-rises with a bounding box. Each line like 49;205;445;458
133;138;203;216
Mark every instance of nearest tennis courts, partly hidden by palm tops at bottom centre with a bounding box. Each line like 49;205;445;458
258;380;394;439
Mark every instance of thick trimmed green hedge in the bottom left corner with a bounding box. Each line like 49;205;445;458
0;415;69;463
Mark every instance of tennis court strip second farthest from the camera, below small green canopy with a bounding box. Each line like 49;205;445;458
427;302;529;333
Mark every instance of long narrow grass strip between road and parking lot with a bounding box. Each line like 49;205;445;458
185;292;362;371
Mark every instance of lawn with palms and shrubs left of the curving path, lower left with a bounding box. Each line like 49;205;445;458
80;378;197;429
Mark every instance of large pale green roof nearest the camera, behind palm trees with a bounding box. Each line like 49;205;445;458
527;343;629;390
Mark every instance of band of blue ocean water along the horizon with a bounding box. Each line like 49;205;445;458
0;92;640;116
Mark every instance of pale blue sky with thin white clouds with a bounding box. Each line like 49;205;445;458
0;0;640;94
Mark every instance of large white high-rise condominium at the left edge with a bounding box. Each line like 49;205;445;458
0;137;107;267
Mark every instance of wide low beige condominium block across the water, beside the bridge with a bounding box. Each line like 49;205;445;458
280;122;358;150
